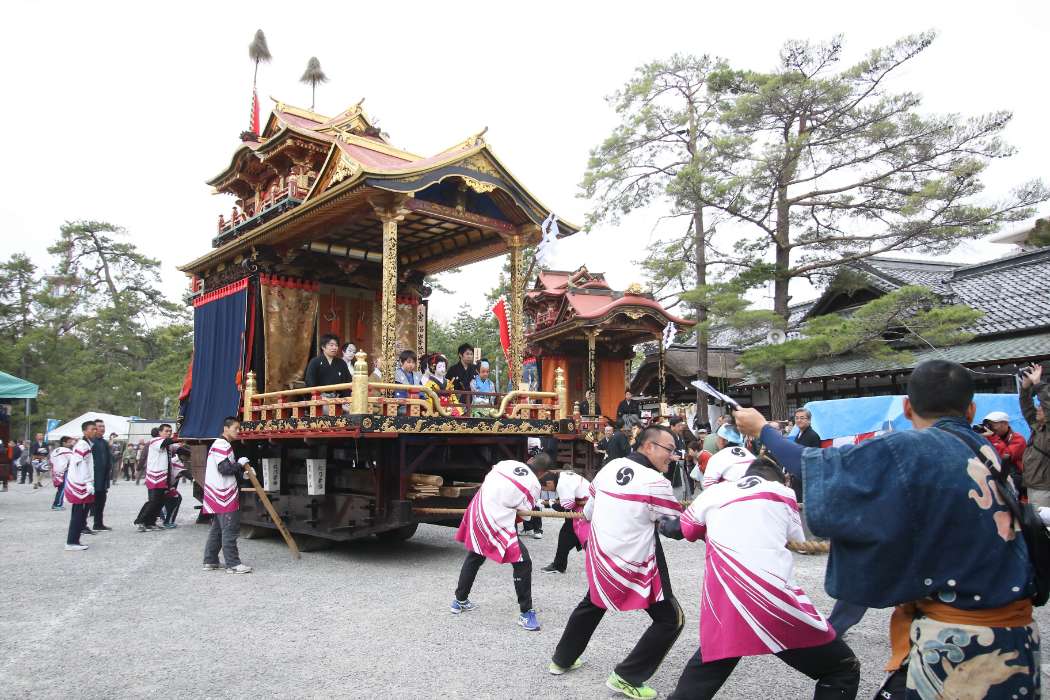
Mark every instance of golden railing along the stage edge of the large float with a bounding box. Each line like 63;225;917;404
242;352;572;421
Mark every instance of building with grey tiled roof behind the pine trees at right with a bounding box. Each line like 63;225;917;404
632;249;1050;407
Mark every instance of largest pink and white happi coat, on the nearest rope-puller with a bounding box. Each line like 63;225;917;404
681;476;835;661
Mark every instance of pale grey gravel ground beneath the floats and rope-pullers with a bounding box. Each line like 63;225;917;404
0;482;1048;700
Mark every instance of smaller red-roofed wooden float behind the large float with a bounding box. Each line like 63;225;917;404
525;267;694;419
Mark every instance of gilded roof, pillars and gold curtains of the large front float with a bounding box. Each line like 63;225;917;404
180;101;578;391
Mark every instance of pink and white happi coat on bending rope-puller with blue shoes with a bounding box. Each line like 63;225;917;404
456;460;540;564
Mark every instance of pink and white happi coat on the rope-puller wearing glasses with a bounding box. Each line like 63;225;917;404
584;458;681;611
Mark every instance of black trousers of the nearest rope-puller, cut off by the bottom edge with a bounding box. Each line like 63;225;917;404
668;639;860;700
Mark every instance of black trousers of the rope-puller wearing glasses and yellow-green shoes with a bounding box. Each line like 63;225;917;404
551;539;685;685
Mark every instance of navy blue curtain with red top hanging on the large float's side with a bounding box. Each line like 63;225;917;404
179;280;248;438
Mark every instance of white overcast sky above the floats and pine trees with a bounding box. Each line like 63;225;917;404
0;0;1050;319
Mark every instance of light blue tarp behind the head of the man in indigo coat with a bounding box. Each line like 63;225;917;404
805;394;1031;440
